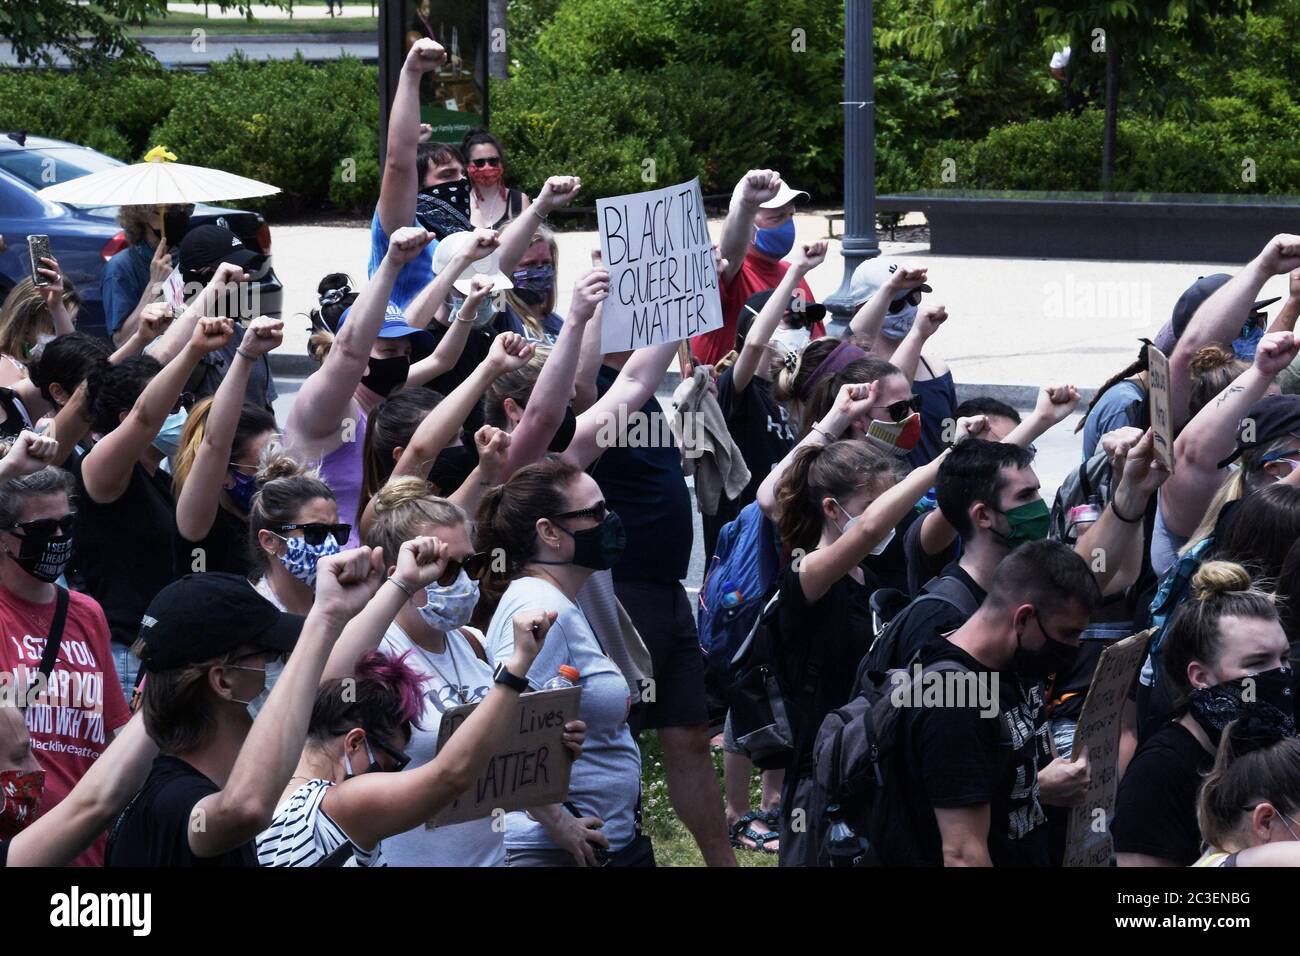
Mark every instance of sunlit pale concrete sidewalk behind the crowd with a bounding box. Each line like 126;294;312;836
258;213;1287;390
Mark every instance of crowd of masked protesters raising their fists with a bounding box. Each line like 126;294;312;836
0;39;1300;866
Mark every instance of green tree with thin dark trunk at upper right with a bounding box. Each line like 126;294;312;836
883;0;1251;187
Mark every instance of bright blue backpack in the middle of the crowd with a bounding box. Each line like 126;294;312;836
696;502;781;696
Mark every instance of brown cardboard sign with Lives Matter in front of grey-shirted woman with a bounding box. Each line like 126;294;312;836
425;687;582;830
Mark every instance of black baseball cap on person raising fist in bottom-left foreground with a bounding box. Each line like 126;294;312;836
139;571;303;671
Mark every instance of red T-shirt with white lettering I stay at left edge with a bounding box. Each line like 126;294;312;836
0;588;131;866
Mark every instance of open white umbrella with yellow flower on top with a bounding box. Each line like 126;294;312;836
36;146;280;206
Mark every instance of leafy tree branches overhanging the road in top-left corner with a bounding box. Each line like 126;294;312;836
0;0;287;68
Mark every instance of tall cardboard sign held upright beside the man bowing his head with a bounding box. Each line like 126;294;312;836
1065;628;1154;866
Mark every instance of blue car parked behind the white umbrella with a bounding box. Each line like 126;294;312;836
0;133;283;336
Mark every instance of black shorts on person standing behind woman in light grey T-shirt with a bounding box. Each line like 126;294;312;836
614;581;709;734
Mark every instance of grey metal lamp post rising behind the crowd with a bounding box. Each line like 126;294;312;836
824;0;880;332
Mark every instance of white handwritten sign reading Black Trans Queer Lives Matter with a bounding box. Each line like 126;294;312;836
595;178;723;352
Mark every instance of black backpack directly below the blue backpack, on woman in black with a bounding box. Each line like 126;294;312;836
724;591;795;770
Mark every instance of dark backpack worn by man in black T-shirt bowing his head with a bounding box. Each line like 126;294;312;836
807;659;1010;866
